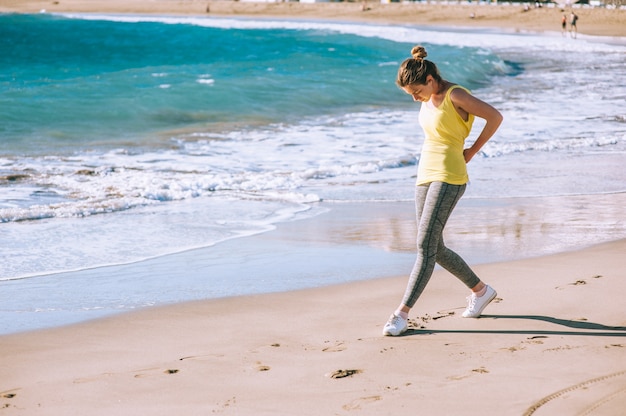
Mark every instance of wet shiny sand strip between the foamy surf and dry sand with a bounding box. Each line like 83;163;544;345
0;192;626;337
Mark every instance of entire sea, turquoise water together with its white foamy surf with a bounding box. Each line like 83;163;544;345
0;14;626;333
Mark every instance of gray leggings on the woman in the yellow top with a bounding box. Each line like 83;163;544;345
402;182;480;308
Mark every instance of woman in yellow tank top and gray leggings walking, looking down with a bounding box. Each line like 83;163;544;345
383;46;502;336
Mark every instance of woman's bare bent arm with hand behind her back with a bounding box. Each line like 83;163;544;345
450;88;503;163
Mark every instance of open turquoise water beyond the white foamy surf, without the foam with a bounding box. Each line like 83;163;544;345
0;14;508;155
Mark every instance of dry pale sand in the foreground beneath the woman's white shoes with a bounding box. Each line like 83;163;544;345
0;239;626;416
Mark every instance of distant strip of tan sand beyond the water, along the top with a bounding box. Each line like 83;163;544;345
0;0;626;38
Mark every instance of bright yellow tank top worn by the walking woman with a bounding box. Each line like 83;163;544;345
417;85;474;185
